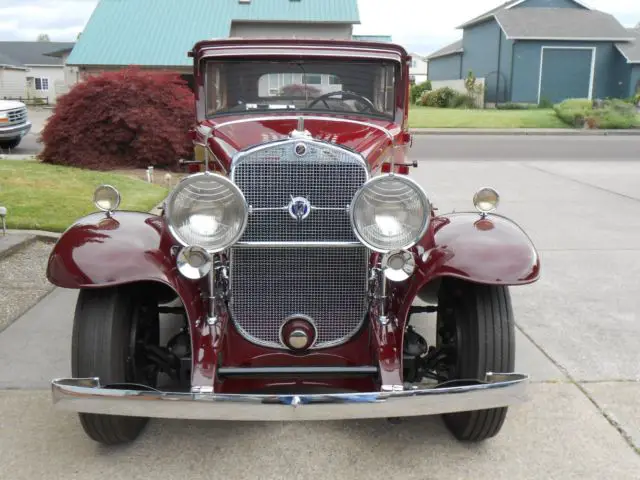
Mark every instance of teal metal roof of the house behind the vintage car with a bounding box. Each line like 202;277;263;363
67;0;360;67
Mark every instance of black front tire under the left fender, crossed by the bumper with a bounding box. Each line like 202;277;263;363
71;287;159;445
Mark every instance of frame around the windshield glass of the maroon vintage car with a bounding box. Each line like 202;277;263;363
199;52;403;121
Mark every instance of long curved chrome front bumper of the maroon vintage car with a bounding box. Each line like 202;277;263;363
52;373;529;421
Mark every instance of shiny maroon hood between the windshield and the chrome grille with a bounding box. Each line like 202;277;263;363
204;115;401;171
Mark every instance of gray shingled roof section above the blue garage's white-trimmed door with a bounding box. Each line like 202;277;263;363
495;8;634;42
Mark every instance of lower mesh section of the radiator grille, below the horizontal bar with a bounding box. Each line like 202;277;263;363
230;247;368;348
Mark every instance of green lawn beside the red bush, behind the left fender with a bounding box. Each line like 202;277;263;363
0;160;168;232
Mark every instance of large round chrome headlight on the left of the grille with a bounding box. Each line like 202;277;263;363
166;172;249;253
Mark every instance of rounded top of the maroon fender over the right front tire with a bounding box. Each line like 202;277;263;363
418;213;540;285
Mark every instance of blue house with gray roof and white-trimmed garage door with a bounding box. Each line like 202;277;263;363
427;0;640;103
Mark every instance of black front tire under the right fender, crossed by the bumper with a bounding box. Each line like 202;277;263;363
438;279;515;442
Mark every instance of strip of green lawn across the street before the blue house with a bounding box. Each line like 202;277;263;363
409;106;568;128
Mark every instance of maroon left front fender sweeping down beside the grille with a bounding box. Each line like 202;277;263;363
47;211;215;386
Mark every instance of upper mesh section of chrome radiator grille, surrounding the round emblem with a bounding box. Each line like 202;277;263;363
234;143;367;242
